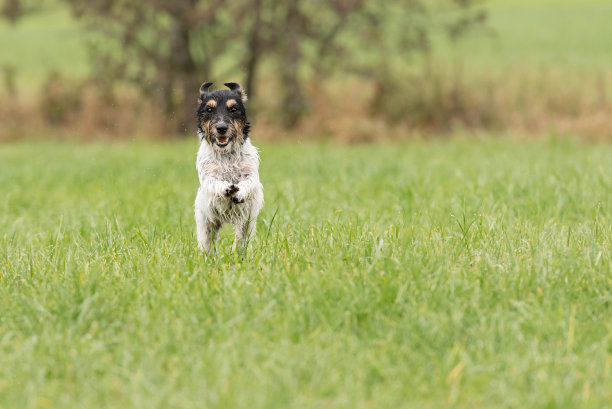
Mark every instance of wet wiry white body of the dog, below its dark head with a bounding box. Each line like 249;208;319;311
195;129;264;253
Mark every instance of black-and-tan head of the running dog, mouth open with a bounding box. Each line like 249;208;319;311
197;82;249;152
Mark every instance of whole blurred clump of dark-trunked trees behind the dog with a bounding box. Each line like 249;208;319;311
63;0;479;131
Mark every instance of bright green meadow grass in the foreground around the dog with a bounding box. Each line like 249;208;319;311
0;141;612;409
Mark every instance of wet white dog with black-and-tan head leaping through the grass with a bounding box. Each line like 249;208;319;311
195;82;264;253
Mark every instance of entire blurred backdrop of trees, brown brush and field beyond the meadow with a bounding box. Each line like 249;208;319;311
0;0;612;142
